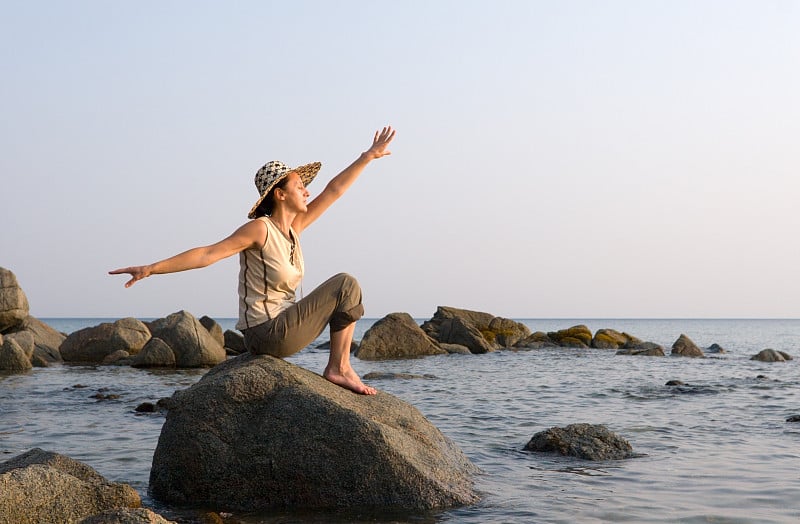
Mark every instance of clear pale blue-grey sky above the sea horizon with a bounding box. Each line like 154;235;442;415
0;0;800;318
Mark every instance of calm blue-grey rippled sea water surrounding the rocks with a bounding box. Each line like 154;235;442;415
0;319;800;524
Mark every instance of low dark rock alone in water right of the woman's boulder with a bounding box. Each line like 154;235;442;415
525;424;633;460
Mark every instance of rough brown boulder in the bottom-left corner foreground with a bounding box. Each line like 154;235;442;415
0;448;141;524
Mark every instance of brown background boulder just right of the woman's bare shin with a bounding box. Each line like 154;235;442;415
356;313;447;360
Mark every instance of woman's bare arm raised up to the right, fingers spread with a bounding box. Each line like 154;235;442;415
292;126;395;234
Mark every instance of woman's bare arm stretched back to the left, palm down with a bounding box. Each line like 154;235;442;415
108;220;267;287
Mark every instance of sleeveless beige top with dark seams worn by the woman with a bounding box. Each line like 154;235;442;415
236;217;304;330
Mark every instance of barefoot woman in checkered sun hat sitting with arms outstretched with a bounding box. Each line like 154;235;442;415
109;126;395;395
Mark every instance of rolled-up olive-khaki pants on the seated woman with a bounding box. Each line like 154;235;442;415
243;273;364;358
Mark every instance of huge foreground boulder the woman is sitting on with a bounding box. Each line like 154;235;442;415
150;354;478;511
